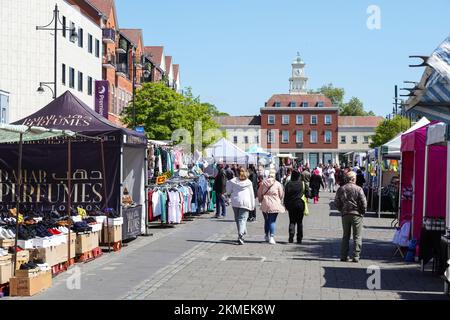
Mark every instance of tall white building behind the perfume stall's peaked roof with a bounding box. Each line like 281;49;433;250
0;0;102;122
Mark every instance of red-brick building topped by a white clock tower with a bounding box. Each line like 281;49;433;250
261;57;339;167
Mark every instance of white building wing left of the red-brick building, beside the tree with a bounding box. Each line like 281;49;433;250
214;116;261;151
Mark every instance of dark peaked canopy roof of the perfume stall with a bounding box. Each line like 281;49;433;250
13;91;147;145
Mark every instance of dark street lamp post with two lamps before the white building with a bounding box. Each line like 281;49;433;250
36;4;78;99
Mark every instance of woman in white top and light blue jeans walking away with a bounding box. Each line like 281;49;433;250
227;167;256;245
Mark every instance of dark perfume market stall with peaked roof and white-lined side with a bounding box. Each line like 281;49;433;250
7;91;147;240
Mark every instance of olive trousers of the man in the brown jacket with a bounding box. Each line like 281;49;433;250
341;214;363;259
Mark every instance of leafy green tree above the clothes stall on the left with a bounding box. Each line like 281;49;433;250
122;81;219;145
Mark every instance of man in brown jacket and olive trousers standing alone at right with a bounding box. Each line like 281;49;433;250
335;171;367;262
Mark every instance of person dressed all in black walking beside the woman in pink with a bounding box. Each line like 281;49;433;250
284;170;309;244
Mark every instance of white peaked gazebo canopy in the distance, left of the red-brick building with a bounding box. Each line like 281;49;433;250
205;138;250;164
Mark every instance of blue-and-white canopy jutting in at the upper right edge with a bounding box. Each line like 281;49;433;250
406;36;450;123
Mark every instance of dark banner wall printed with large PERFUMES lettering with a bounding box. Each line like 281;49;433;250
0;141;120;212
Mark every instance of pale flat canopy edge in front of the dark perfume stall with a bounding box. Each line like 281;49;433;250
0;123;75;143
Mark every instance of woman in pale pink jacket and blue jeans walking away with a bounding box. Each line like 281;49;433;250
258;170;286;244
